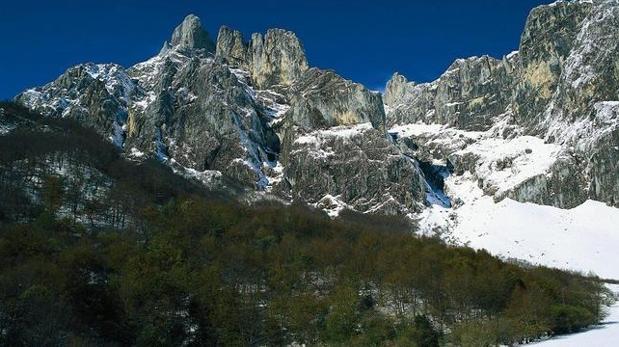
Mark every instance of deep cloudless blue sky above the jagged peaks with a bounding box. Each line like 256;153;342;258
0;0;551;99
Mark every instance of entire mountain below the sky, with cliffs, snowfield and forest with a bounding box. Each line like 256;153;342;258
0;0;619;346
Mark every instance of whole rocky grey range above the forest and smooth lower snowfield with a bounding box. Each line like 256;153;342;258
16;0;619;245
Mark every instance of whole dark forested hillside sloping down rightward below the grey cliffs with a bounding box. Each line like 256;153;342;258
0;103;611;346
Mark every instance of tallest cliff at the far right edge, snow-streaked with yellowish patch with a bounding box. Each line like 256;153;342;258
514;1;619;206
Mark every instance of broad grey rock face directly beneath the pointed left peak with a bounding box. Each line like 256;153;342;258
128;51;279;188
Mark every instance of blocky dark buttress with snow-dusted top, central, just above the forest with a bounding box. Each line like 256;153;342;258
280;123;425;214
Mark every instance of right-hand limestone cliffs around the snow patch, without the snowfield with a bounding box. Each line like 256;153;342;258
385;0;619;207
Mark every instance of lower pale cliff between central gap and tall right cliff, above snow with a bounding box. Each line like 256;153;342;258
385;56;514;130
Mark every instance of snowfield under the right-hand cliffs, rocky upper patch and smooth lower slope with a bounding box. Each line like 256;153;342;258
402;117;619;279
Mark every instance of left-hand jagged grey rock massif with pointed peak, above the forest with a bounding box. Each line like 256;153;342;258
16;15;426;218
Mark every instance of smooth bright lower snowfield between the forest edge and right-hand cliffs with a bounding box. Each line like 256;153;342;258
421;177;619;279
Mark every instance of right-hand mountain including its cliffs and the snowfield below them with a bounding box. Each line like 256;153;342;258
384;1;619;278
